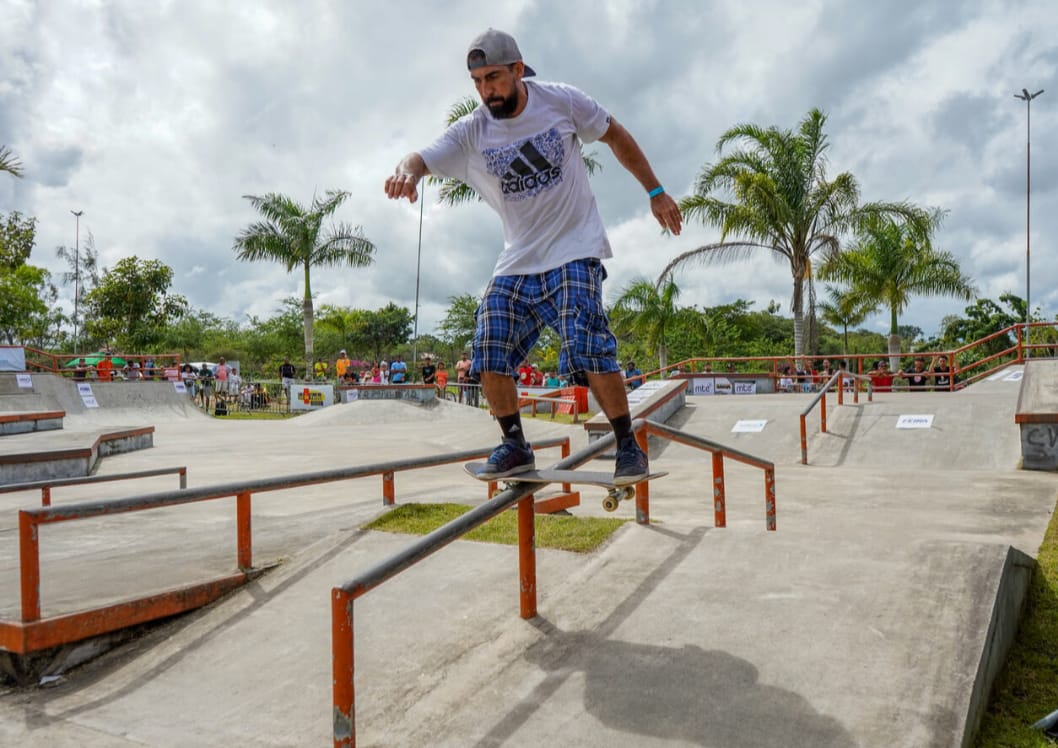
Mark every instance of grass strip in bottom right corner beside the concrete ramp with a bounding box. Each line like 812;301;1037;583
974;497;1058;748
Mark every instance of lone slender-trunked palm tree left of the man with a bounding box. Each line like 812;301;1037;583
232;190;375;377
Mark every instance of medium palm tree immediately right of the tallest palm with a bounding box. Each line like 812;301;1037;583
819;211;977;358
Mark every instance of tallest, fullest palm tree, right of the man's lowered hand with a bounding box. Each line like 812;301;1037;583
659;109;928;358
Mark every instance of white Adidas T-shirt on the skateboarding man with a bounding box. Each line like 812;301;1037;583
420;80;613;275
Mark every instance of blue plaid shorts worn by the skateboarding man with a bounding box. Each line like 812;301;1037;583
471;258;621;377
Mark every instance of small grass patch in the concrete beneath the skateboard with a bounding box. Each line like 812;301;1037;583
363;504;628;553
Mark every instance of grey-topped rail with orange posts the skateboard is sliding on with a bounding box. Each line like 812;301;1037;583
330;419;776;748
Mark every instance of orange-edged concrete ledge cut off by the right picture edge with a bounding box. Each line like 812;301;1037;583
1014;360;1058;470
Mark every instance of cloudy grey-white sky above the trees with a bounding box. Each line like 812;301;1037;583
0;0;1058;344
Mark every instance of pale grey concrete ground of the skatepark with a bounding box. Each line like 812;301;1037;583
0;367;1058;748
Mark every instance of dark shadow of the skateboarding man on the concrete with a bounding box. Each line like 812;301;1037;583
478;619;856;748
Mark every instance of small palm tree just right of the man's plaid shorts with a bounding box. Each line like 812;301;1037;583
610;278;708;369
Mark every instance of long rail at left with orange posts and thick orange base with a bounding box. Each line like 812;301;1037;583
0;437;569;654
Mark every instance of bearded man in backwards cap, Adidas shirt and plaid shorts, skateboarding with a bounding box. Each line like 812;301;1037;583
385;29;682;485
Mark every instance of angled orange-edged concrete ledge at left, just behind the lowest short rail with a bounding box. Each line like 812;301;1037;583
0;426;154;485
